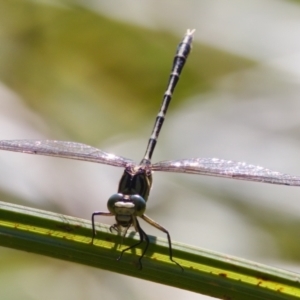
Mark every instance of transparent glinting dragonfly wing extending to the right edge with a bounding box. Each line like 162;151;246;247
152;158;300;186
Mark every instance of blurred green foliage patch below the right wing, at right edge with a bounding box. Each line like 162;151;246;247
183;176;300;264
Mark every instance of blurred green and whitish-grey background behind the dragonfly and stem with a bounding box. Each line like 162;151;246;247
0;0;300;299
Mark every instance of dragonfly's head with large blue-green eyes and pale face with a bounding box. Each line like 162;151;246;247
107;193;146;227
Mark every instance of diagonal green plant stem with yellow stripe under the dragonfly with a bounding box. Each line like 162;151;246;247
0;202;300;300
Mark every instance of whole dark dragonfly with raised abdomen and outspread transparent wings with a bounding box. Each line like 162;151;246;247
0;30;300;269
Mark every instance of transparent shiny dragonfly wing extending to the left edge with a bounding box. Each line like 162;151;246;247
0;140;135;167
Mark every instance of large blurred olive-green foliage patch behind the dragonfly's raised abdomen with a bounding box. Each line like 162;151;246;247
0;0;253;144
